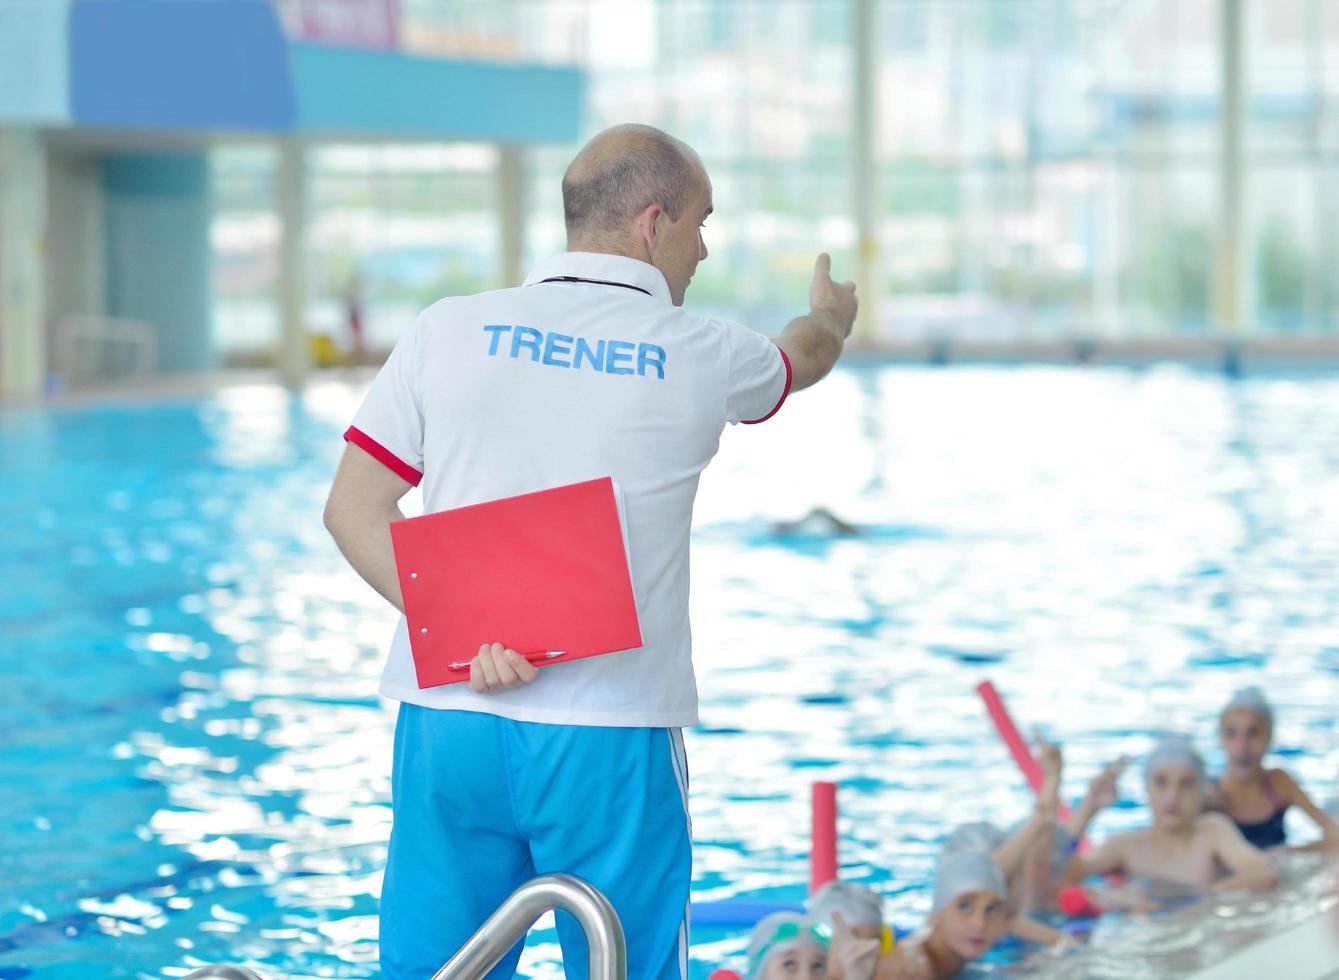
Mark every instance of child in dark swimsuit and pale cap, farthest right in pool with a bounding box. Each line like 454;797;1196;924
1212;687;1339;850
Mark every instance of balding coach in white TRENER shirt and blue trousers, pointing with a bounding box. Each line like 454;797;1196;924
325;126;856;980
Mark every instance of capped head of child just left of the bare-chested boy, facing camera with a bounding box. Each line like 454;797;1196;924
931;851;1008;961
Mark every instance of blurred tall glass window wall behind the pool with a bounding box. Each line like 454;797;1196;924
0;0;1339;398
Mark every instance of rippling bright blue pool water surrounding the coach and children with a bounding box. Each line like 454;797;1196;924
0;365;1339;979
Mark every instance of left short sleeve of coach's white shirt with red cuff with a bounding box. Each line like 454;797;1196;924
344;320;423;486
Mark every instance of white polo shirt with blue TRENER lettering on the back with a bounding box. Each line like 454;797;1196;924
344;252;790;727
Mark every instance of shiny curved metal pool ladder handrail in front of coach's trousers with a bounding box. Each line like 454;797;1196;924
432;874;628;980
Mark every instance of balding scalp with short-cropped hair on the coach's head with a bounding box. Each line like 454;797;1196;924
562;123;707;242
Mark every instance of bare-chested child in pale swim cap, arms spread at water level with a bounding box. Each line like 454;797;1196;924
1066;738;1277;894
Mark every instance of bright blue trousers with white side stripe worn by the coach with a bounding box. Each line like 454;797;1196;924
382;703;692;980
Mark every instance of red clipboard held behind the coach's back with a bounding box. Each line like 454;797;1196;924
391;477;641;689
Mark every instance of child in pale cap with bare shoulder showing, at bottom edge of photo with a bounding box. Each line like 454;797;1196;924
828;851;1008;980
